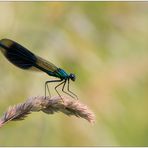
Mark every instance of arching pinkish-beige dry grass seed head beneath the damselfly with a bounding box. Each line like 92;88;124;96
0;96;95;127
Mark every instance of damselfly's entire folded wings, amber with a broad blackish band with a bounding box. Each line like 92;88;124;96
0;39;58;75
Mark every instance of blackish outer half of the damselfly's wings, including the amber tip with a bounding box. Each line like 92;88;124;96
0;39;37;69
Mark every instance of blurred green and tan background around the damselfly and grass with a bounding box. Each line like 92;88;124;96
0;2;148;146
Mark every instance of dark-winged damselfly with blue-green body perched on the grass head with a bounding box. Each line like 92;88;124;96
0;39;75;99
